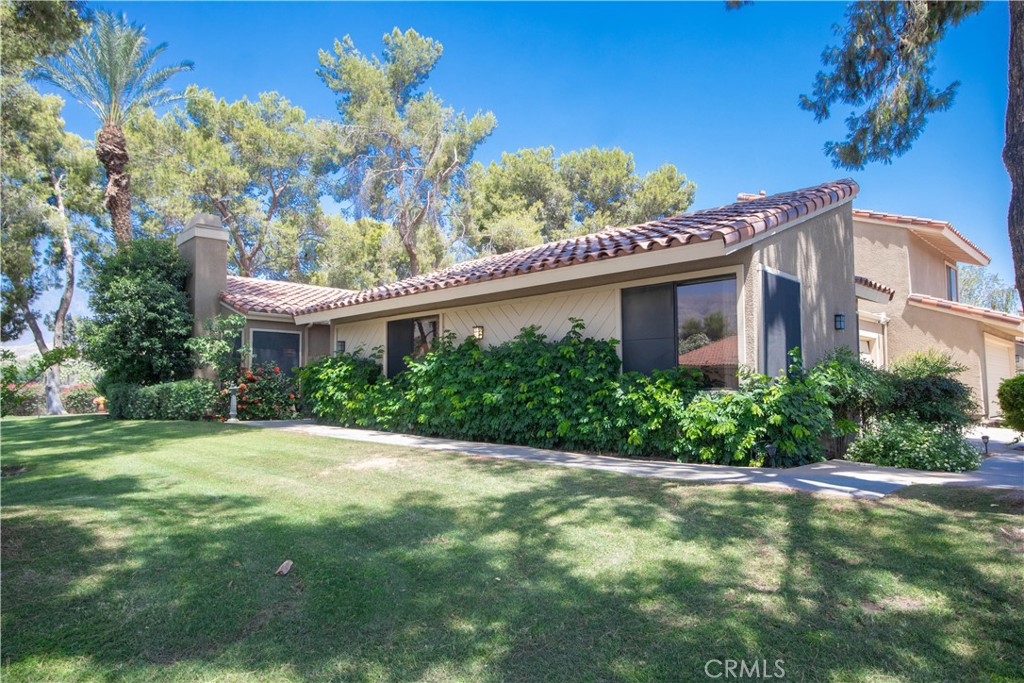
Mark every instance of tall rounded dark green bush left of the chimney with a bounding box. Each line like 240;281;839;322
81;239;193;385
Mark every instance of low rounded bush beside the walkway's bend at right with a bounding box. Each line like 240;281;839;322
847;415;981;472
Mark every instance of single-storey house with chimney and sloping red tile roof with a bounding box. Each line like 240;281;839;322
178;179;864;387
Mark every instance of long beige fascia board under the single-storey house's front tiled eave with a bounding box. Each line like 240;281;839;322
295;240;729;325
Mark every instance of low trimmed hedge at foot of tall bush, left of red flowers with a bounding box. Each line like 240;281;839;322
106;379;217;420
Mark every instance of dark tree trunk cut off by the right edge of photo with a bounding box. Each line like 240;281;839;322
1002;2;1024;301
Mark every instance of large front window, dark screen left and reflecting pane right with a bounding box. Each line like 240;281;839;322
622;274;739;387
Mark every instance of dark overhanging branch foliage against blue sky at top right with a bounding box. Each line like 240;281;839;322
800;0;981;169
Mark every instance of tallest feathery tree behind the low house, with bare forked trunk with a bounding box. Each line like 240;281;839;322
317;29;497;275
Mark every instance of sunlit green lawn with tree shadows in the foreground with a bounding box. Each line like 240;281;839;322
0;417;1024;682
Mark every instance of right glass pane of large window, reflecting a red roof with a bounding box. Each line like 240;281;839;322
676;275;739;388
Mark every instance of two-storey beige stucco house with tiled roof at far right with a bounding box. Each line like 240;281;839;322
853;209;1024;419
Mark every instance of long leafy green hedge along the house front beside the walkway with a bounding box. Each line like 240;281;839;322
299;321;847;466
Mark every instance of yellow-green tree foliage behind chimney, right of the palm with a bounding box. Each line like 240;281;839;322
127;86;338;282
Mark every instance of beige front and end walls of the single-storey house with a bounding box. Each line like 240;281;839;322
331;205;857;368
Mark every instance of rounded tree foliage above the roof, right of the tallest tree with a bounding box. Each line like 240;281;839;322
462;146;696;253
